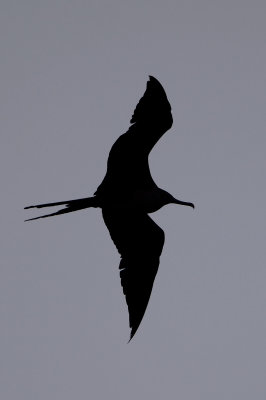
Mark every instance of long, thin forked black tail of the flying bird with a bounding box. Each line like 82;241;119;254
24;197;99;221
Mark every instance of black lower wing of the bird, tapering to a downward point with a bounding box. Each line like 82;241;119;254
103;208;164;339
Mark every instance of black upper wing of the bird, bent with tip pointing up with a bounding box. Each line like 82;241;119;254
95;76;173;195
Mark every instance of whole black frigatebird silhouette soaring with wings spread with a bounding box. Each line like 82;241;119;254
25;76;194;340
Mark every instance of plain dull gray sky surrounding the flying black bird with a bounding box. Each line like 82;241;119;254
0;0;266;400
